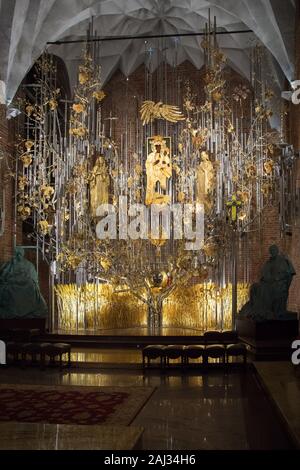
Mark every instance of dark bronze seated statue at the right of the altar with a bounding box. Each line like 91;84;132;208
240;245;296;321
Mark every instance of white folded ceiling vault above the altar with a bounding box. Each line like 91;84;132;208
0;0;295;103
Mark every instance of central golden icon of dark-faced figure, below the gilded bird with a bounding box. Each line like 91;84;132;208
146;136;172;205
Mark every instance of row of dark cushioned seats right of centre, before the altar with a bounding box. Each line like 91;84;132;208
143;343;247;368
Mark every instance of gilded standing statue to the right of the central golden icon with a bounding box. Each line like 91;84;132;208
196;152;215;205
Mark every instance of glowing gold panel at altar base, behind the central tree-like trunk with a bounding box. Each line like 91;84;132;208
55;283;249;331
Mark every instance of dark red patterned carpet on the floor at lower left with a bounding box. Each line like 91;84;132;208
0;384;154;426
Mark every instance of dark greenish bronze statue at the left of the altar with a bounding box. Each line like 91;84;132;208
0;248;48;319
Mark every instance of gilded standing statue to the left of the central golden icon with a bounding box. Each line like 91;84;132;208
90;155;110;217
